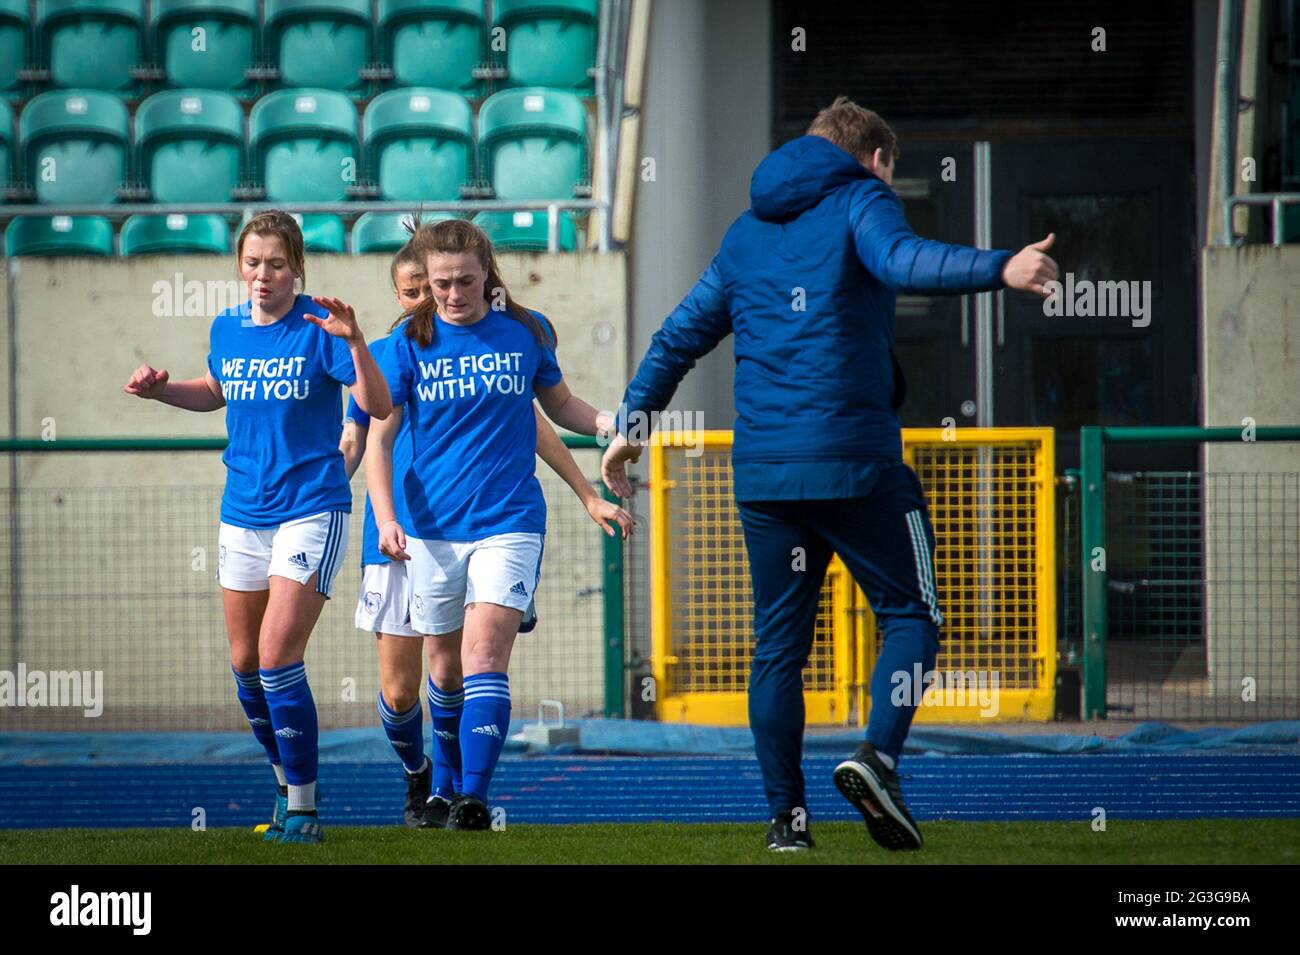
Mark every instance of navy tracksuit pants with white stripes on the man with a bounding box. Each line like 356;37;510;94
738;461;943;816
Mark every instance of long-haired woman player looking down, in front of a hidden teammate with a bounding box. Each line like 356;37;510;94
365;220;613;829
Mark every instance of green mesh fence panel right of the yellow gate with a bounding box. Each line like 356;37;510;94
1062;429;1300;722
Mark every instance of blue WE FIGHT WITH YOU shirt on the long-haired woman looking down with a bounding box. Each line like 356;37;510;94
380;309;563;541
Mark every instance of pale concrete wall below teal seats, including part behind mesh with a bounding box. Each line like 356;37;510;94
0;253;628;729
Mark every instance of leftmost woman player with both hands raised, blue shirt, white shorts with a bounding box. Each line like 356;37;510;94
126;210;393;842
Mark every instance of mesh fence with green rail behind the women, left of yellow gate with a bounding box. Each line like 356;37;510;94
0;438;624;732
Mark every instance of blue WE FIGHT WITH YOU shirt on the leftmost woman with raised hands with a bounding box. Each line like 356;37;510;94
208;295;356;529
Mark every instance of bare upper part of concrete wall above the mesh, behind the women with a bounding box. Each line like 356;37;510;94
5;253;627;486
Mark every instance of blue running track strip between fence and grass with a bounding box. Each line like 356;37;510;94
0;752;1300;829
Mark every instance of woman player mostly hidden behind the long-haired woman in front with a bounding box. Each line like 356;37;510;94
339;235;632;829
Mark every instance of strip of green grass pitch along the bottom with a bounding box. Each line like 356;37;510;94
0;819;1300;865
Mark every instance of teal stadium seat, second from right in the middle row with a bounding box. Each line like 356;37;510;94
364;87;475;200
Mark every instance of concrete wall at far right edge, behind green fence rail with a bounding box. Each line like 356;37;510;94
1201;246;1300;699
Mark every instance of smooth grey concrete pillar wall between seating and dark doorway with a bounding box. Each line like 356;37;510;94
629;0;764;436
